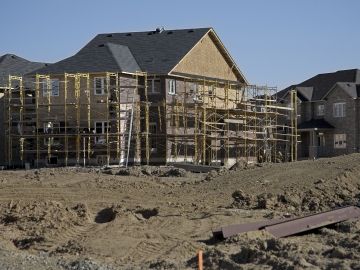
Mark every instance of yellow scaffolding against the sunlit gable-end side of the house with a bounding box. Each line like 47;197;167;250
166;79;297;166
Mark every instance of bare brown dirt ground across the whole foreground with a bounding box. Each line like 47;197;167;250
0;154;360;270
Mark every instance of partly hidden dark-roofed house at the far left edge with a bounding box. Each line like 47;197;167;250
0;54;47;165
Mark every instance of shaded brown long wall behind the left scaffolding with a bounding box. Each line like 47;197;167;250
5;73;143;166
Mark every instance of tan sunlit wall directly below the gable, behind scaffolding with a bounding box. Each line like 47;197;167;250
165;77;243;164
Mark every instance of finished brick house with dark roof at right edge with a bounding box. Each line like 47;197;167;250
278;69;360;158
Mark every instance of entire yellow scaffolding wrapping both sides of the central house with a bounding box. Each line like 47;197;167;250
4;72;298;167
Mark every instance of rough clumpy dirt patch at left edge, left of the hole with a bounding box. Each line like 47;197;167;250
0;201;88;249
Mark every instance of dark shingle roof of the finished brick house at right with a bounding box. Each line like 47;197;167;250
278;69;360;101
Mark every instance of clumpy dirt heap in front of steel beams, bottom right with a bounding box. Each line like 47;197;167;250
188;225;360;269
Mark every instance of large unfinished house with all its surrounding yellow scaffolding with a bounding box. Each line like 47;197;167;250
0;28;297;167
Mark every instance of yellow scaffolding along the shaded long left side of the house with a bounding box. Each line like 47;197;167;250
4;72;149;167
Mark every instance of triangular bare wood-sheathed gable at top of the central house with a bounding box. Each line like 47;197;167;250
173;34;238;81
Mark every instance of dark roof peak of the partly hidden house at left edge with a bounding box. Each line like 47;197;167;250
0;54;47;86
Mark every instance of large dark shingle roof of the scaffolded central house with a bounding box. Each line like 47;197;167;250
31;28;245;80
